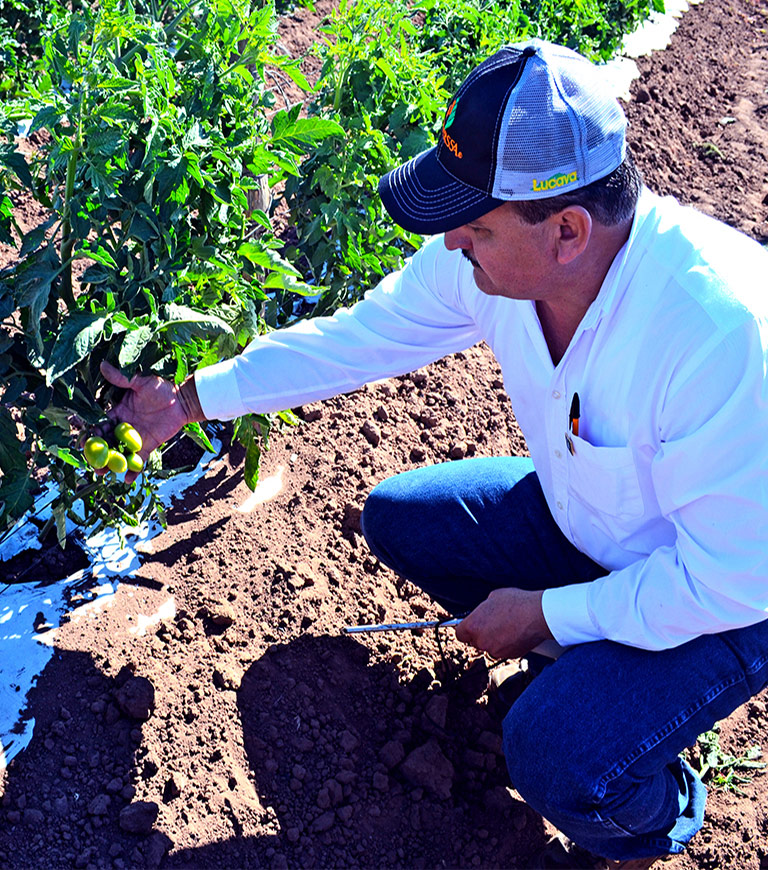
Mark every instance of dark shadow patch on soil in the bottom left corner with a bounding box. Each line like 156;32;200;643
0;649;172;868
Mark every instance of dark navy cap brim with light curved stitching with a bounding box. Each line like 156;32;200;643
379;147;503;236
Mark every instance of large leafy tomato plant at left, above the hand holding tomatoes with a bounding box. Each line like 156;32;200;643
0;0;340;540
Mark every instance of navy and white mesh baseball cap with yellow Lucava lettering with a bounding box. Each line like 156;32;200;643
379;39;627;235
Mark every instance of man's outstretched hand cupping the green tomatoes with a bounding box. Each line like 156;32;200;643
101;361;204;483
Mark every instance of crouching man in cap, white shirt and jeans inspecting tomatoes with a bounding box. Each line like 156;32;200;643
105;40;768;867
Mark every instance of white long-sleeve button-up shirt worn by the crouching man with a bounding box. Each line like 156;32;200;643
196;190;768;649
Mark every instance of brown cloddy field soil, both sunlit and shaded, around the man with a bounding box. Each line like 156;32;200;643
0;0;768;870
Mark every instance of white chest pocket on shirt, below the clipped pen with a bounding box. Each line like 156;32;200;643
568;436;643;520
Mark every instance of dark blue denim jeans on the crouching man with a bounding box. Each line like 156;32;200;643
362;457;768;859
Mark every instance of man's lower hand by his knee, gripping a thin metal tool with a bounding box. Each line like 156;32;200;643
456;589;552;659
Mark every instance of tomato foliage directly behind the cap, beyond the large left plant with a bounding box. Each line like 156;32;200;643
284;0;662;319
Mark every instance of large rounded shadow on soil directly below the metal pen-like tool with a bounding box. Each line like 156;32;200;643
167;636;546;868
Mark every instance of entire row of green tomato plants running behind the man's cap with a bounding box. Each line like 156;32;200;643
0;0;659;545
